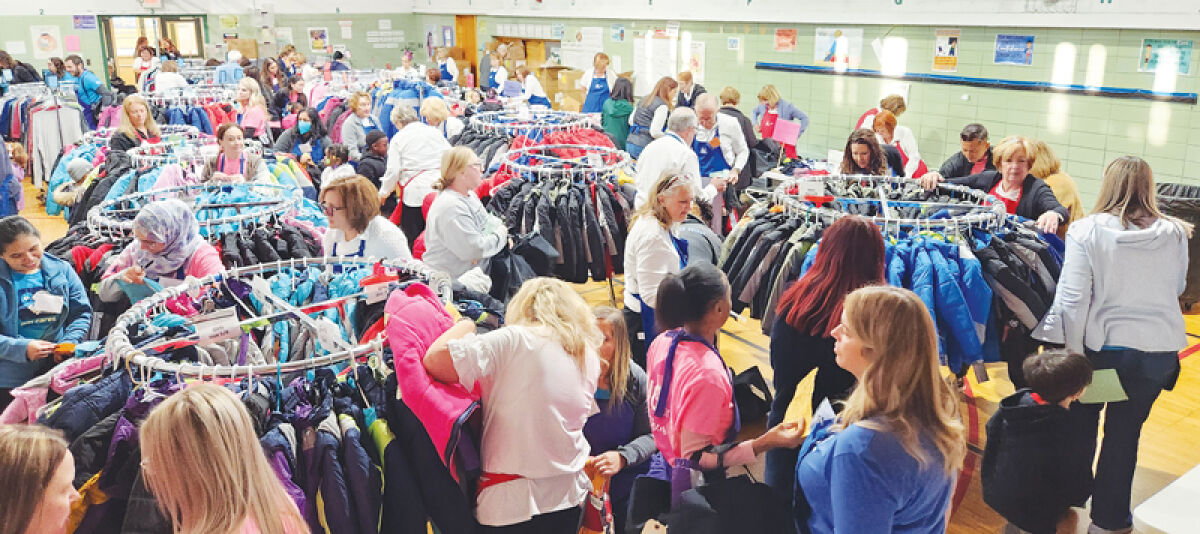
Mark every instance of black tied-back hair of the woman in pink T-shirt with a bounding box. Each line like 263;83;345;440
654;263;730;330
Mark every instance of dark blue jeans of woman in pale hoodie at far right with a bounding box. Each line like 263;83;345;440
1081;349;1180;530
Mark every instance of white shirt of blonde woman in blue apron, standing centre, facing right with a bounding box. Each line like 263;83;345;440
624;215;682;313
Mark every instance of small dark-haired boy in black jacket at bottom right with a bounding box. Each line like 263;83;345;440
982;350;1092;534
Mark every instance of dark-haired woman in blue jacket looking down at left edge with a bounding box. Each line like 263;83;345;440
0;215;91;410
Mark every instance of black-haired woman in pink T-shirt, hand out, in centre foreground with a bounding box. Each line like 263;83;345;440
630;263;803;522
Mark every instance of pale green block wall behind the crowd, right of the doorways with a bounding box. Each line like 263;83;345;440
479;17;1200;206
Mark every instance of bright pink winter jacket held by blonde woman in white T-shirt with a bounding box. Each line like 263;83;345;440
384;283;479;473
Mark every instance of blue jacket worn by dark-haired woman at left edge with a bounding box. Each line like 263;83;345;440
0;254;91;389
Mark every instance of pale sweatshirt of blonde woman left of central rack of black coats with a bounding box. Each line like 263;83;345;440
422;190;509;278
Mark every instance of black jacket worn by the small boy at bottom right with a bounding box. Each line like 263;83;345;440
982;389;1094;533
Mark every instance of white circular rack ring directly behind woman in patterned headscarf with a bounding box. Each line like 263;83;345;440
88;184;304;236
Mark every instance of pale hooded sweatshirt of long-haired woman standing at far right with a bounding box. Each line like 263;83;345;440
1033;214;1188;354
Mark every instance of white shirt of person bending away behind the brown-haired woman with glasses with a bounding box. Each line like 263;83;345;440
379;122;450;208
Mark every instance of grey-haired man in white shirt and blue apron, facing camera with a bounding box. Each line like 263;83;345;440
691;92;750;235
